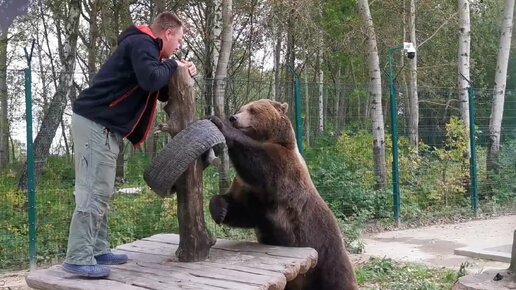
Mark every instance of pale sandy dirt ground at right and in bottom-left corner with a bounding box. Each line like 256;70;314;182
0;215;516;290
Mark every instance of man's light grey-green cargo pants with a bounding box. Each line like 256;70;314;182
65;114;122;265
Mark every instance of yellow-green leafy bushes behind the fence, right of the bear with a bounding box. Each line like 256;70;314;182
328;118;482;219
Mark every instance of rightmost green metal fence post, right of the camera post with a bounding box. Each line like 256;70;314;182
468;83;478;216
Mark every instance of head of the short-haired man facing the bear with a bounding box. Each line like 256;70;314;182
151;12;183;58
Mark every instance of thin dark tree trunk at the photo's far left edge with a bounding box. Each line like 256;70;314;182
0;29;9;170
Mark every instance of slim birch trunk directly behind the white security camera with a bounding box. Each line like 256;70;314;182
408;0;419;150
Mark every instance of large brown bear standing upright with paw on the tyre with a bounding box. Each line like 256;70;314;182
209;99;358;290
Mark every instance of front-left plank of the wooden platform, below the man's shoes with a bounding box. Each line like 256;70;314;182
25;265;145;290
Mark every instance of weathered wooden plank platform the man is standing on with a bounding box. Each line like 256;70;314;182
26;234;317;290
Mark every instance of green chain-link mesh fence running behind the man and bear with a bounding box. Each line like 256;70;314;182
0;72;516;270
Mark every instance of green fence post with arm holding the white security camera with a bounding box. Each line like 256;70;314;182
387;45;403;226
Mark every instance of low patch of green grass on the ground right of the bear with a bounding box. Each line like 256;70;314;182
355;258;458;290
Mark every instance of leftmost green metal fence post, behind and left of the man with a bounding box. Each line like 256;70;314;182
24;40;37;271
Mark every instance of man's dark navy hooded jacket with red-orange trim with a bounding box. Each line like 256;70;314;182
72;25;177;146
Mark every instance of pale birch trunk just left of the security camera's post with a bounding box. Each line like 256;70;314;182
358;0;387;189
